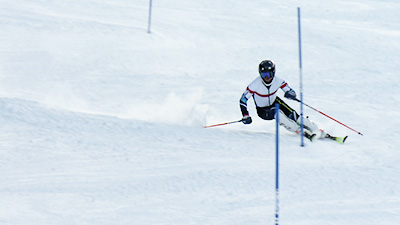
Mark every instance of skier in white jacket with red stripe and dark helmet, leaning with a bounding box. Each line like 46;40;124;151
240;60;318;141
